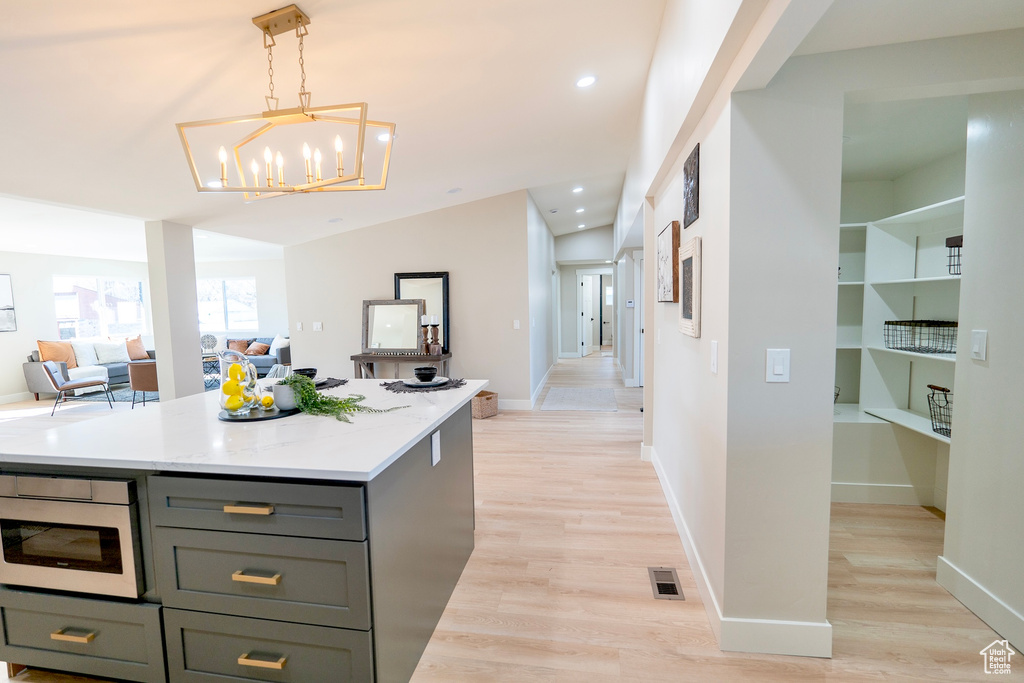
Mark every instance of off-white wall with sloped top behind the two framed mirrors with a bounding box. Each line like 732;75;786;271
285;190;530;408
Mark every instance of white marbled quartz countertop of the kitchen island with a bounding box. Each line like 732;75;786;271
0;380;487;481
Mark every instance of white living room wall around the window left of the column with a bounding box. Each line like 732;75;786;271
0;252;153;402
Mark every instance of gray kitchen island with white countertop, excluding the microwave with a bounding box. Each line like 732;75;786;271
0;380;486;681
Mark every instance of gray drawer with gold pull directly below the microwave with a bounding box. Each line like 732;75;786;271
0;589;166;683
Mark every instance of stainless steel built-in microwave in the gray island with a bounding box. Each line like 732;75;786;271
0;474;144;598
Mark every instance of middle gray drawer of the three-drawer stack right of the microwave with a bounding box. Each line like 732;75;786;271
153;526;370;630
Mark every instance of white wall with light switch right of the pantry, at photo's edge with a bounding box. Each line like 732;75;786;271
938;91;1024;651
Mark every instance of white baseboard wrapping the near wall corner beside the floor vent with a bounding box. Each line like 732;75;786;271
655;445;831;657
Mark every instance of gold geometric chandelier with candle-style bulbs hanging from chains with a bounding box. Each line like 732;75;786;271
177;5;394;200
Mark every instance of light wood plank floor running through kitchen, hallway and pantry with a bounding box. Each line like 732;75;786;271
0;354;999;683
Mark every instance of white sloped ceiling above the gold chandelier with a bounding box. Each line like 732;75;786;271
0;0;665;258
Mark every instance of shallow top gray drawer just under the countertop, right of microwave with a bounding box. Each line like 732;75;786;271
148;475;367;541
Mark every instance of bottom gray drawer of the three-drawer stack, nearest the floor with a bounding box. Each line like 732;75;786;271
164;609;374;683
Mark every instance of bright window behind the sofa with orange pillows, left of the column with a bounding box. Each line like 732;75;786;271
53;275;147;339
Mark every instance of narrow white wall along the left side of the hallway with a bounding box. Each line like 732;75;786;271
532;194;556;403
